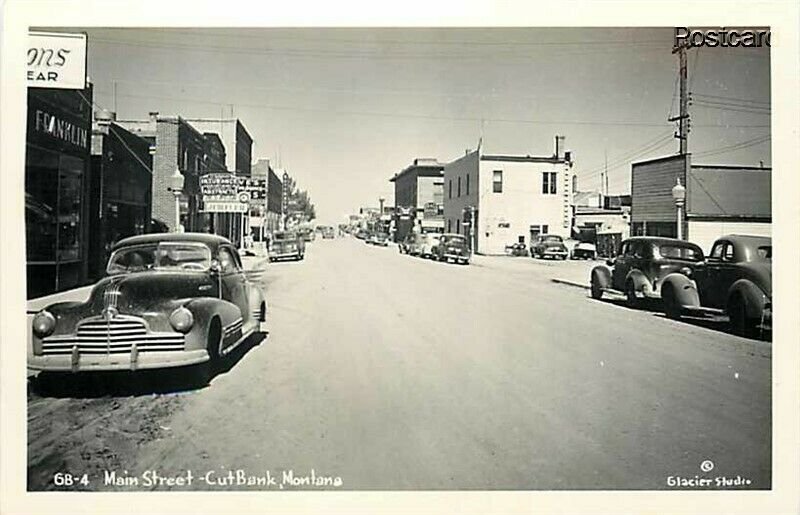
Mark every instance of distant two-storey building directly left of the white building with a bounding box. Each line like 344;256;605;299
389;158;444;241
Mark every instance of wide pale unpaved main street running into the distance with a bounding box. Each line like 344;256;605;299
28;239;771;490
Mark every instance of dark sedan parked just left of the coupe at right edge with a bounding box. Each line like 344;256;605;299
591;236;703;307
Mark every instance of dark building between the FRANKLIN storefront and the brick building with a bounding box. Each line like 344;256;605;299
89;112;153;279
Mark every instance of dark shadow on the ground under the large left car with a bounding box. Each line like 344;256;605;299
28;332;267;399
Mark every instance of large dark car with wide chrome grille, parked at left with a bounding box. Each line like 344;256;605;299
28;233;267;382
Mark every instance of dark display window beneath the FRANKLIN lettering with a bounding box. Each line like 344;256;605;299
25;146;84;263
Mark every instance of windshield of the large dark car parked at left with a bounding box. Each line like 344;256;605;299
106;242;211;275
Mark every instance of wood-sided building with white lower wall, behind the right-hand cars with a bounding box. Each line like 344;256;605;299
631;154;772;252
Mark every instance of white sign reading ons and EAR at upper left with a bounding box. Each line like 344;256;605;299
26;32;86;89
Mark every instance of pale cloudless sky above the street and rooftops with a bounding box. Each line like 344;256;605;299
64;28;771;223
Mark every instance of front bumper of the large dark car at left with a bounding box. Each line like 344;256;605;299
28;347;209;372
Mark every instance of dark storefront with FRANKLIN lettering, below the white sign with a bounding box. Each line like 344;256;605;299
25;86;92;298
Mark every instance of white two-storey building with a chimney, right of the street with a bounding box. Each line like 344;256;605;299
444;136;572;254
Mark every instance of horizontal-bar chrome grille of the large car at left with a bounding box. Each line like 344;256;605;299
42;316;184;355
